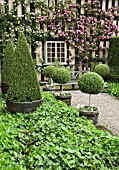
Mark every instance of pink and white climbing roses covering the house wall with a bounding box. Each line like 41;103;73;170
0;0;117;65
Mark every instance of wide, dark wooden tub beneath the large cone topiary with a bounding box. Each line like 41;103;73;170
6;99;43;113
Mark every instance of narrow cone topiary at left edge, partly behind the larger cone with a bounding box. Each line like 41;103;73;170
1;39;15;94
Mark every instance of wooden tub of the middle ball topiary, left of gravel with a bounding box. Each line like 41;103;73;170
55;95;72;106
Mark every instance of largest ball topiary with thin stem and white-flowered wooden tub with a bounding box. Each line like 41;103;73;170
78;72;104;124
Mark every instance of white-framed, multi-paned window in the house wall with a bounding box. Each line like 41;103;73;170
45;41;67;64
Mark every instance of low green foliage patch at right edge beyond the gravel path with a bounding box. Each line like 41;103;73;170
107;82;119;98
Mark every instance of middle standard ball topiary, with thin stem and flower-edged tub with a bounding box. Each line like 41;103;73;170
52;68;71;105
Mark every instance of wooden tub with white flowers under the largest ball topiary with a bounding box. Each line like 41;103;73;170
79;106;99;125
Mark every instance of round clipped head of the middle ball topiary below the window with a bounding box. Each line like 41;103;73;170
52;68;71;84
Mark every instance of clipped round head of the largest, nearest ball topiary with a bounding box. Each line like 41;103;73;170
78;72;104;94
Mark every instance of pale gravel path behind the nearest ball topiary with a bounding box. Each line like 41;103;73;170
71;91;119;135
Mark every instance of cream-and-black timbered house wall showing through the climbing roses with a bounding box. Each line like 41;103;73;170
0;0;119;79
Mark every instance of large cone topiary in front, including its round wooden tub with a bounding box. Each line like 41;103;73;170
7;32;42;112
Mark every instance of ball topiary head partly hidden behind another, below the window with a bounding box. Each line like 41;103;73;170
43;66;55;78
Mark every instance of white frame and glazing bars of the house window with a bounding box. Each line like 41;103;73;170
45;41;67;65
